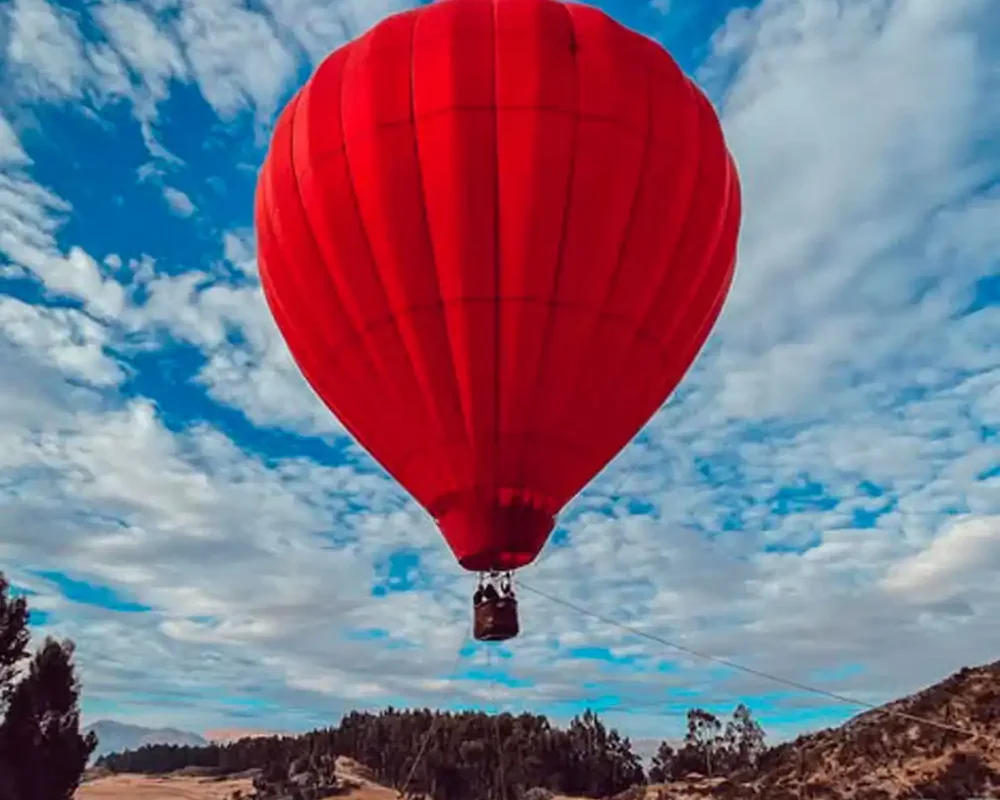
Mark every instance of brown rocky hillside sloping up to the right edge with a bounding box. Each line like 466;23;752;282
649;662;1000;800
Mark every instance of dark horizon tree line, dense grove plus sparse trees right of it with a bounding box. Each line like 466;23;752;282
98;705;765;800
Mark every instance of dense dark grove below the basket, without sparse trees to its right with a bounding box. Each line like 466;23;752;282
98;708;644;800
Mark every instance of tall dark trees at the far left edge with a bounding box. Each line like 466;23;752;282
0;575;97;800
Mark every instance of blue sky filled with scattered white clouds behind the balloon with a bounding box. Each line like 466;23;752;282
0;0;1000;752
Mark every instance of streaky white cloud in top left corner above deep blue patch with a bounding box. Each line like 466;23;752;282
4;0;410;162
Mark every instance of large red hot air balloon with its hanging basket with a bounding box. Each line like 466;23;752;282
256;0;740;638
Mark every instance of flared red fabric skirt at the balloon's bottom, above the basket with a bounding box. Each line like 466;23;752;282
435;497;556;572
